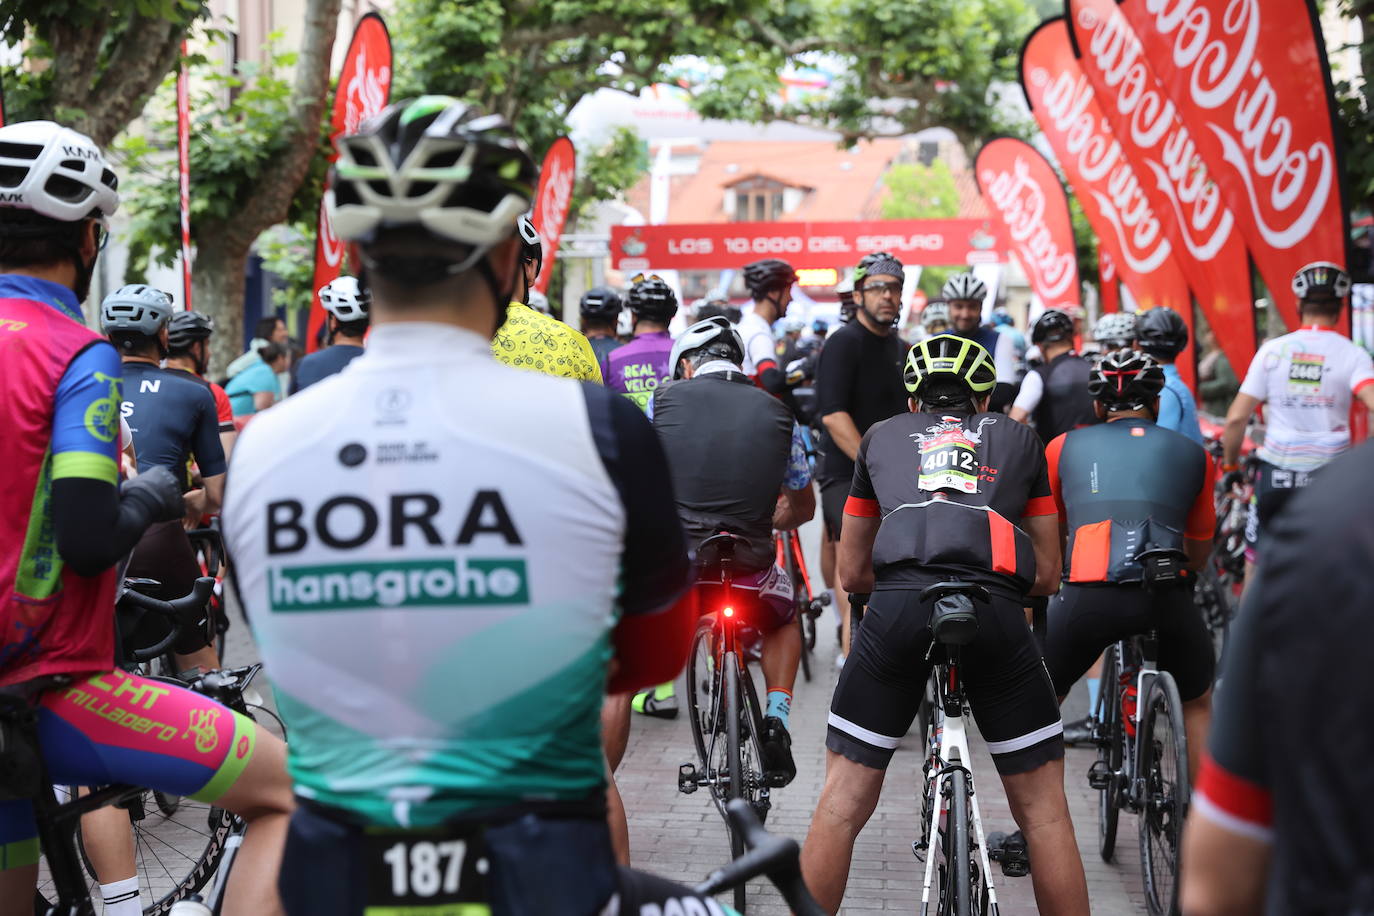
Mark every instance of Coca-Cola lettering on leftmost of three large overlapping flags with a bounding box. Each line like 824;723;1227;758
1032;71;1173;275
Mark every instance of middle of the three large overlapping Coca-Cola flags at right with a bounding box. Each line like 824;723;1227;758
1065;0;1256;372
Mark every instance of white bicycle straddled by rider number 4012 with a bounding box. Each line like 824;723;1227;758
911;581;998;916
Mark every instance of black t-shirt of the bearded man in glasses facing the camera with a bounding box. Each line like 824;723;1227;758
816;319;907;481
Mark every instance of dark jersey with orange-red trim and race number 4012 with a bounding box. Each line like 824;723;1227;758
845;412;1055;597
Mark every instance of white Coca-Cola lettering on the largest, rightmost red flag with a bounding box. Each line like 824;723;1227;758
1129;0;1336;249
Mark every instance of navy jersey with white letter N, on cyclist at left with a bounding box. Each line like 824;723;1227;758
122;363;227;489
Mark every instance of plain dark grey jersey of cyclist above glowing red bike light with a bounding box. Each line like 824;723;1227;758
654;372;793;571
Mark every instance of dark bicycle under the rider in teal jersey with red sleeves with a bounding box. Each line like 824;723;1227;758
1088;551;1191;916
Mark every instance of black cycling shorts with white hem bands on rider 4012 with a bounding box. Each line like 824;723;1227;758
826;580;1063;773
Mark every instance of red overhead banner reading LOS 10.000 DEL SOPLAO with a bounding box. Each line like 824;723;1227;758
610;220;1009;272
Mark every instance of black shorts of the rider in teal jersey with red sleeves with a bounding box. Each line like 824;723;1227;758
1044;584;1216;700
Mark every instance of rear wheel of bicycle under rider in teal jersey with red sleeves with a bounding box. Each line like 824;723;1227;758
1138;672;1190;916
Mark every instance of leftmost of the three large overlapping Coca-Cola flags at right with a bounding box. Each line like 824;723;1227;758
1021;16;1195;387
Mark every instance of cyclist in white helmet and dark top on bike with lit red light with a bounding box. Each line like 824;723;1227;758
653;317;816;786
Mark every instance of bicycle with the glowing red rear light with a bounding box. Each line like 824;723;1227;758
677;531;772;912
